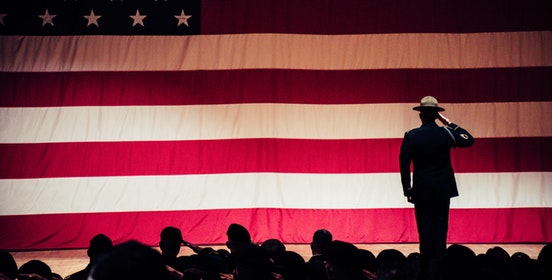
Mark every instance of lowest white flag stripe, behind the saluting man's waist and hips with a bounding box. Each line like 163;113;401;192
0;172;552;215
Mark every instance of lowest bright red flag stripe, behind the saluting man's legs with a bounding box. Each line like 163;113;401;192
0;207;552;250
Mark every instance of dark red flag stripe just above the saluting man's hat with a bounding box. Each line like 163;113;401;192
0;67;552;107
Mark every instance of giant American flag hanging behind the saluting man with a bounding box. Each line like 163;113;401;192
0;0;552;250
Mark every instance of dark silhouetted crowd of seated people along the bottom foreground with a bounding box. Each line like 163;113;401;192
0;224;552;280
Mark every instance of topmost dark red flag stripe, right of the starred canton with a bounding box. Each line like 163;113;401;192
201;0;552;34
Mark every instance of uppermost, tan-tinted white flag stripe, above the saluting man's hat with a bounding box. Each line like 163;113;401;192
0;31;552;72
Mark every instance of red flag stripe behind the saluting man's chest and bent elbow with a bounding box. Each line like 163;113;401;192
0;137;552;179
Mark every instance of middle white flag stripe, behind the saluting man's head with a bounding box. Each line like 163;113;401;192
0;102;552;143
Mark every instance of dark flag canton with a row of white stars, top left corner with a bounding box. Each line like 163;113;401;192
0;0;201;35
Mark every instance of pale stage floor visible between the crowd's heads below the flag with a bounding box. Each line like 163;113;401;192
11;243;545;277
